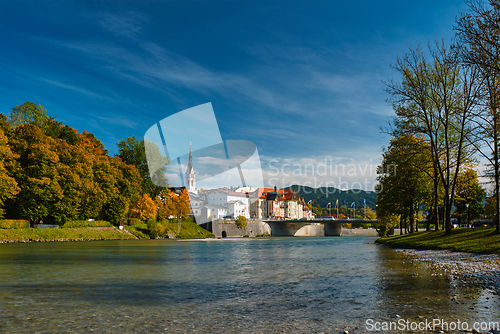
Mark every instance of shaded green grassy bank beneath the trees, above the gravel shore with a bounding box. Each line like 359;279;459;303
376;227;500;254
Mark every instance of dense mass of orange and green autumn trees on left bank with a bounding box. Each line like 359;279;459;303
0;102;151;223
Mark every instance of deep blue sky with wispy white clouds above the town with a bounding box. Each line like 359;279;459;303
0;0;466;189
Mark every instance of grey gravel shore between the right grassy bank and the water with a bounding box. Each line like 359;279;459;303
396;249;500;295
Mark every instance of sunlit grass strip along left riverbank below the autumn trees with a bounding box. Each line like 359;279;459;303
0;227;135;243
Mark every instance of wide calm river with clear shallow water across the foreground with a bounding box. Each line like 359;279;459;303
0;236;500;333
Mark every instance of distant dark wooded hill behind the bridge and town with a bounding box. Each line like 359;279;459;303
285;185;377;210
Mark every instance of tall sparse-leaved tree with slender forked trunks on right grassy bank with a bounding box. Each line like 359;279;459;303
387;43;481;233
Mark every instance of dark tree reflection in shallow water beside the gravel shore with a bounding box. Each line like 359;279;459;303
377;248;500;329
